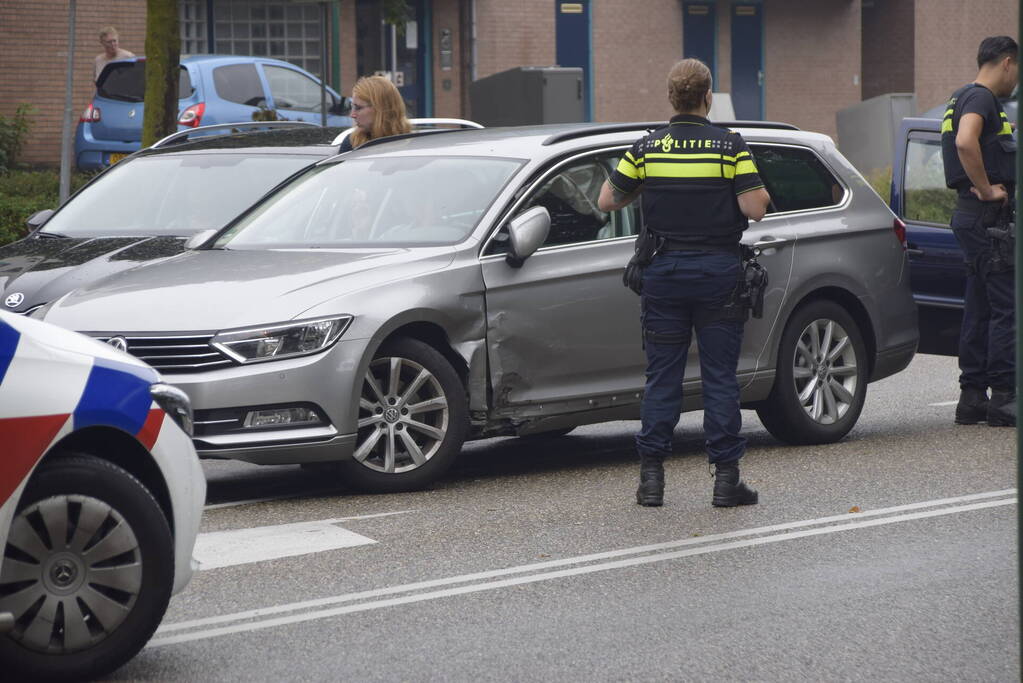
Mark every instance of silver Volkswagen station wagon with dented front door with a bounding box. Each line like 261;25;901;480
38;123;918;492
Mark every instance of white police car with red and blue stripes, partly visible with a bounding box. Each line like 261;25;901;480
0;312;206;680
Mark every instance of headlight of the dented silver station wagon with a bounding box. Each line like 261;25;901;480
210;315;352;363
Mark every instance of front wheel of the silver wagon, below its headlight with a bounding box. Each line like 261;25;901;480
343;339;469;493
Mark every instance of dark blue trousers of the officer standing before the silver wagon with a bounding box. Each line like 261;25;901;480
636;252;746;464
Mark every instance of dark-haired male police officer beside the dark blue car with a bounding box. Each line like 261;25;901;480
941;36;1019;426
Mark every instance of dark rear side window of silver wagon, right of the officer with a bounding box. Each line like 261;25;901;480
750;144;845;213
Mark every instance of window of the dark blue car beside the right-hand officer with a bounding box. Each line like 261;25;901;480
902;137;955;226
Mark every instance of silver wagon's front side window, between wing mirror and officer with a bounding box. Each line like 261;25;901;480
488;152;639;254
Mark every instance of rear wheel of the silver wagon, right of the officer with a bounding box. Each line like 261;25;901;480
757;300;868;444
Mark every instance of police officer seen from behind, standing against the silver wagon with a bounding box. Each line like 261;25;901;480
598;59;770;507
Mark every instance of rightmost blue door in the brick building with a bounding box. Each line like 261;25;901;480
731;2;764;121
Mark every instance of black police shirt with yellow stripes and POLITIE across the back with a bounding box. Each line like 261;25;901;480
610;115;764;247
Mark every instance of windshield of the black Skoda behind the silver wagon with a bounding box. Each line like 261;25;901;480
43;153;321;236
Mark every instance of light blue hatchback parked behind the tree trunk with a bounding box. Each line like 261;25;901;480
75;54;353;170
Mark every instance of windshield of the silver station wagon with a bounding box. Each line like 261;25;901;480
215;156;522;248
